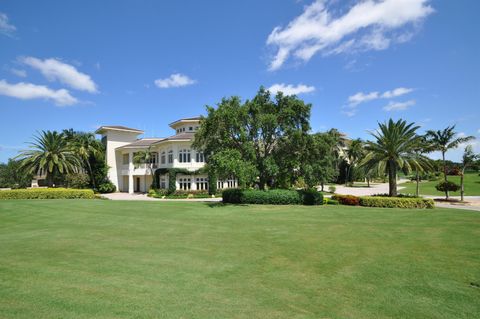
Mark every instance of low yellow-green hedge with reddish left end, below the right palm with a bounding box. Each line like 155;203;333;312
332;194;435;208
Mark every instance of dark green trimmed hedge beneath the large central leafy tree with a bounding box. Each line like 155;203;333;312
222;189;323;205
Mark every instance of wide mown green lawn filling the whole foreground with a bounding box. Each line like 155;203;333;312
0;200;480;319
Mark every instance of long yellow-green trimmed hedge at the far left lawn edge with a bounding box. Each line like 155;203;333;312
0;188;95;199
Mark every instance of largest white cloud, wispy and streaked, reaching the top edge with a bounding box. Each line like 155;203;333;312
267;0;434;70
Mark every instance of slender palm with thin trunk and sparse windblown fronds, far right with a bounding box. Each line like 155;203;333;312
426;125;475;199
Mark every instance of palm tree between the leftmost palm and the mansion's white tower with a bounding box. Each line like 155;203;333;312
63;129;103;188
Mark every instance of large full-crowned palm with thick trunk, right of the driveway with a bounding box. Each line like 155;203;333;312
360;119;424;196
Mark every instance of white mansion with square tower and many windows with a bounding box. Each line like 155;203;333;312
95;117;237;193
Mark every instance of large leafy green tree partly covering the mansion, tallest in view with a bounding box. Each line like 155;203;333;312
193;87;311;189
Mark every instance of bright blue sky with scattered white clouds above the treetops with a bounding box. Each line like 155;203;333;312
0;0;480;162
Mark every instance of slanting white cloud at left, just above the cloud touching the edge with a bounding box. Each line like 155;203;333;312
19;57;98;93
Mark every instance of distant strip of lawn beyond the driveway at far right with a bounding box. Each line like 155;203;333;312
400;173;480;196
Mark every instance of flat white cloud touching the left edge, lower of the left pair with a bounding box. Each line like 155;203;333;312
0;80;78;106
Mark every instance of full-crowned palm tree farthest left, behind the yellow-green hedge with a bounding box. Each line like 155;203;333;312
17;131;81;187
